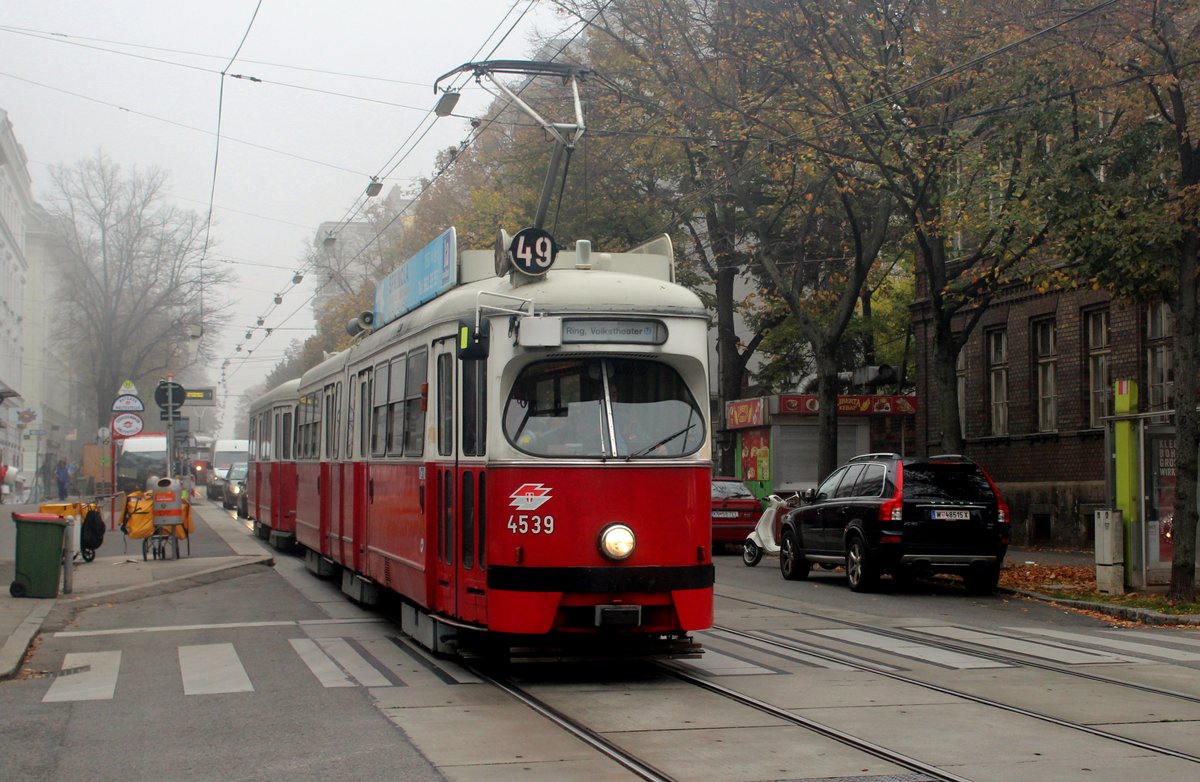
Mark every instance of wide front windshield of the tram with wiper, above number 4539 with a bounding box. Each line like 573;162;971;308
504;357;708;459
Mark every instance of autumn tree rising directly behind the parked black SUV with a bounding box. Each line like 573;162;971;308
764;0;1084;452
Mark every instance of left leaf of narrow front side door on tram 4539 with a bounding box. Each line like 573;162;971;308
430;341;462;616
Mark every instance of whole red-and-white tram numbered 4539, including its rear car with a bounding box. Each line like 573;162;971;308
251;229;714;654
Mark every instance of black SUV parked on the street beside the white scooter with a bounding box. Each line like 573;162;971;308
779;453;1009;594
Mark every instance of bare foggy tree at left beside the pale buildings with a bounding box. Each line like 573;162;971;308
49;151;229;427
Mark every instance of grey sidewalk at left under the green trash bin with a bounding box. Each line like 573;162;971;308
0;500;275;679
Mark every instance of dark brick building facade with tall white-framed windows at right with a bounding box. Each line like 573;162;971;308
913;278;1174;545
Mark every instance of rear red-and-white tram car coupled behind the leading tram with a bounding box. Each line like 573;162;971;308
246;379;300;548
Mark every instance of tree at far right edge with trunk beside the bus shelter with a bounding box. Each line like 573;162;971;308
1054;0;1200;601
